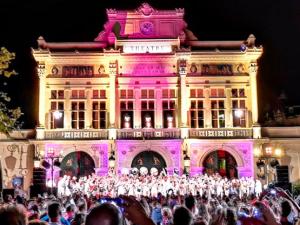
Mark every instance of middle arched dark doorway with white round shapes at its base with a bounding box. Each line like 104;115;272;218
131;151;167;173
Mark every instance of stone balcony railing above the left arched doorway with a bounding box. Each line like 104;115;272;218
45;130;108;140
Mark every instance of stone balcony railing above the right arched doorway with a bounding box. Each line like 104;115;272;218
189;128;252;138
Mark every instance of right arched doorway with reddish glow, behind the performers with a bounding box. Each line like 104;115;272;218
203;150;237;178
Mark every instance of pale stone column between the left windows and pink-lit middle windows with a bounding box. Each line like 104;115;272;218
108;61;118;139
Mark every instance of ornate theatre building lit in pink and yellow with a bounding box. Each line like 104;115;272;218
1;4;269;189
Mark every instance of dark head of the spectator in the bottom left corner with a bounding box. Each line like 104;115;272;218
0;204;27;225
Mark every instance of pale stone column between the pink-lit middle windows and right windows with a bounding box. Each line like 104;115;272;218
179;59;188;138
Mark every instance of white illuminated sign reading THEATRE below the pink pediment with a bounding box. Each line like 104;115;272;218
123;42;172;53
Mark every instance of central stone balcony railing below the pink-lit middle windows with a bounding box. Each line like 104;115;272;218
117;128;180;139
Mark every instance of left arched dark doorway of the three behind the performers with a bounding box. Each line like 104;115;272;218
60;151;95;178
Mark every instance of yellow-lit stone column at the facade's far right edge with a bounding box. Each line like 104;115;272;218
249;62;261;138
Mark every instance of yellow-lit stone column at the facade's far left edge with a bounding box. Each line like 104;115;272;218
36;62;46;139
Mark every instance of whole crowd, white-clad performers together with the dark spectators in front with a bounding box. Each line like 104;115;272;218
0;175;300;225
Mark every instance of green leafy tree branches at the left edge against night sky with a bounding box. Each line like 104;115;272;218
0;47;22;136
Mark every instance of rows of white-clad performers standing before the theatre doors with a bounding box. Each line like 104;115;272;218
57;174;262;197
